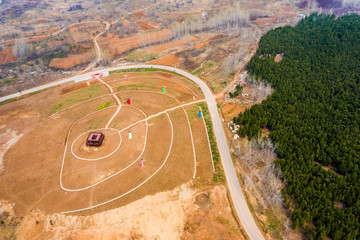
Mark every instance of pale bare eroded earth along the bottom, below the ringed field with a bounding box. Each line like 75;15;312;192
14;184;245;240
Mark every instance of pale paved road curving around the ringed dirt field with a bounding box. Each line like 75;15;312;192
0;64;264;240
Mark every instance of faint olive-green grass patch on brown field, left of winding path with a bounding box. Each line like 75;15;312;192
51;85;106;113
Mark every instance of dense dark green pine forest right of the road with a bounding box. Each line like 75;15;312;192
234;14;360;239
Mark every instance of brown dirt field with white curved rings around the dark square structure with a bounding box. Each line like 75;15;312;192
0;72;212;225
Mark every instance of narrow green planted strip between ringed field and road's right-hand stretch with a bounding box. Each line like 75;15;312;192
198;103;225;183
